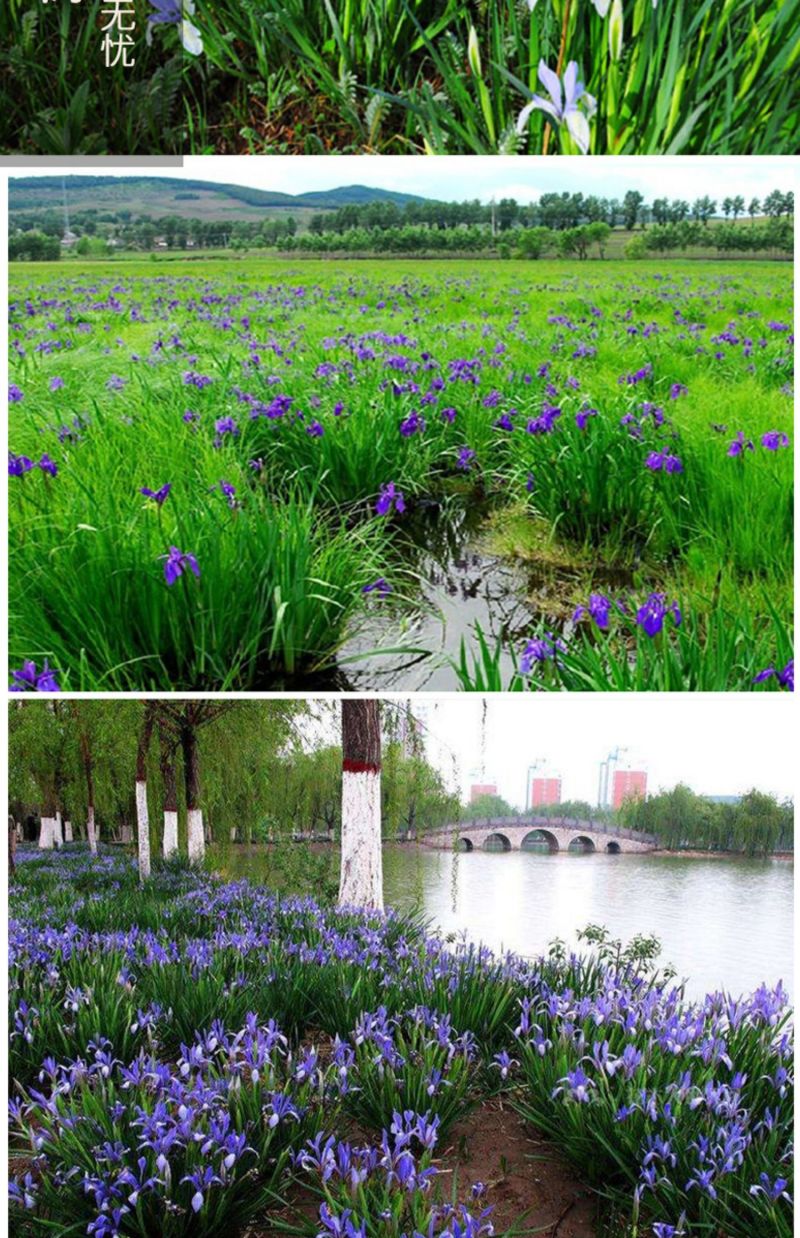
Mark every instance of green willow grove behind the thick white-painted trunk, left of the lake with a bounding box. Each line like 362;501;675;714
9;699;459;859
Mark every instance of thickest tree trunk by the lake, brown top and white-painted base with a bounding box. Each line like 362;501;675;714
339;697;384;910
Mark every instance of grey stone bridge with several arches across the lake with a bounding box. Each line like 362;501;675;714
421;816;658;854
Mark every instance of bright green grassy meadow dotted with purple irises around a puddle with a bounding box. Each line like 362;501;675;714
10;258;793;690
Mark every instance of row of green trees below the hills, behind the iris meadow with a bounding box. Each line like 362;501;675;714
9;189;794;261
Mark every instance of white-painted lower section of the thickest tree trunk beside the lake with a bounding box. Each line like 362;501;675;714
339;769;384;911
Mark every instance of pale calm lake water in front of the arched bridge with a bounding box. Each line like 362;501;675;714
384;847;794;997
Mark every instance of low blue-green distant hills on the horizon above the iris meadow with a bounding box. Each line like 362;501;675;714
9;174;426;220
